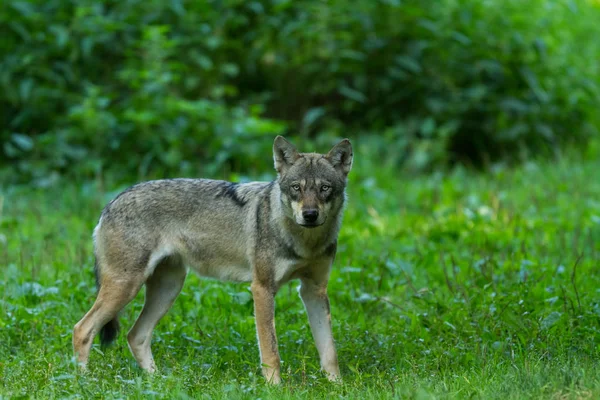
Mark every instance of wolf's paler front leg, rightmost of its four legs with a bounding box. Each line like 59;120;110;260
300;278;341;381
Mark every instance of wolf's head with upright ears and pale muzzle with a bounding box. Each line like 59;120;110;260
273;136;352;228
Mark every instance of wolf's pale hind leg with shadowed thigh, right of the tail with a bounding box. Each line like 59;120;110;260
127;257;187;373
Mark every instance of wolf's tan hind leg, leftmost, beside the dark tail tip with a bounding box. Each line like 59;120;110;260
73;276;143;368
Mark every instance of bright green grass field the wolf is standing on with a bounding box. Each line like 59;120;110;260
0;150;600;399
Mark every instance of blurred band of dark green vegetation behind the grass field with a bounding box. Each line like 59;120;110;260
0;0;600;185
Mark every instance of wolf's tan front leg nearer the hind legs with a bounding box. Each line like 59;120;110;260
251;281;281;385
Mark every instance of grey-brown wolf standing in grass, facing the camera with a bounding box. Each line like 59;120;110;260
73;136;353;384
